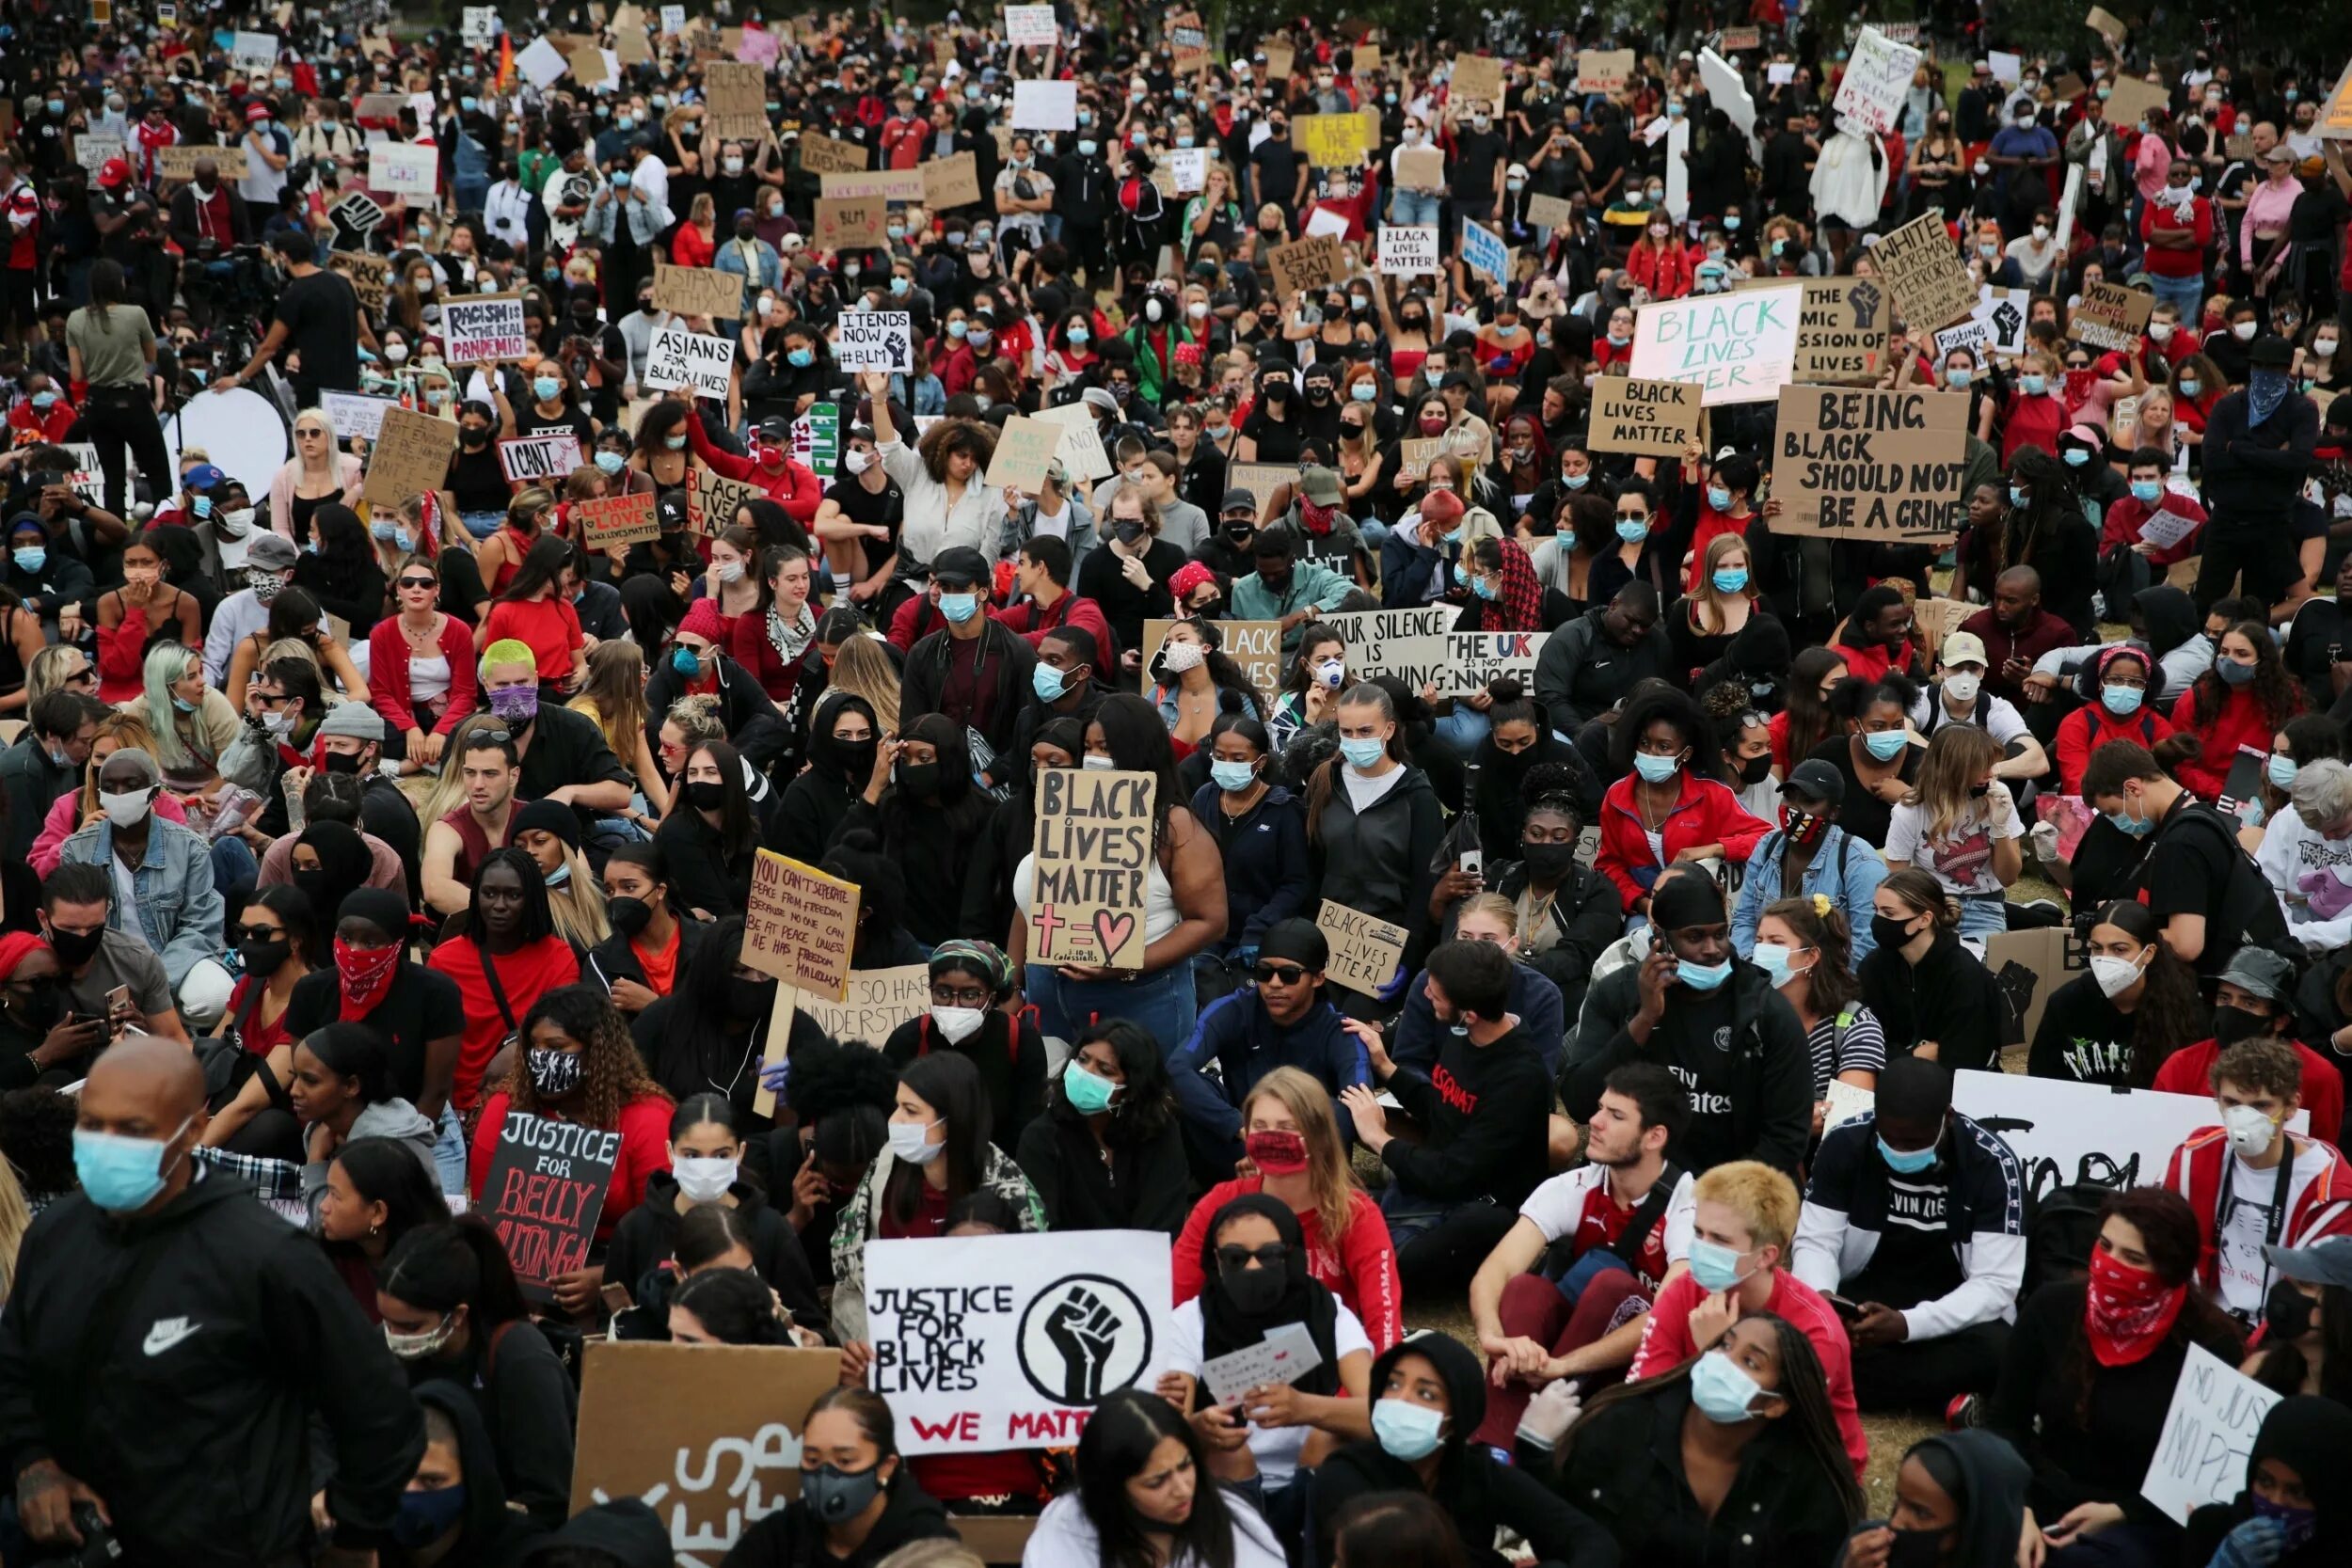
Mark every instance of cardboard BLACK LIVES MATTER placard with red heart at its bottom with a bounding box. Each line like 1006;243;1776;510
1028;768;1160;969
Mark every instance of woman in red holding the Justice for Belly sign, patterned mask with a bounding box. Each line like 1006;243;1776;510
466;985;673;1317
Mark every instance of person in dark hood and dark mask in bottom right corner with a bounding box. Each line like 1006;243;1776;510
2181;1394;2352;1568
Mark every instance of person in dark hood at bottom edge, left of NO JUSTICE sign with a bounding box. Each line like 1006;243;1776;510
1837;1432;2032;1568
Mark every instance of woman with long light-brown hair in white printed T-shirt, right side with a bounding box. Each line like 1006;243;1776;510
1886;724;2026;936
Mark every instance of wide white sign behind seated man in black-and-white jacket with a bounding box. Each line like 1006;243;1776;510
1952;1071;2312;1195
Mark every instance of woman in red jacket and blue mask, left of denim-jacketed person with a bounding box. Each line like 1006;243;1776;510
1593;689;1772;919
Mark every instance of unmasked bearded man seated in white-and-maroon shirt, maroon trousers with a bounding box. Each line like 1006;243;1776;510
1470;1063;1692;1444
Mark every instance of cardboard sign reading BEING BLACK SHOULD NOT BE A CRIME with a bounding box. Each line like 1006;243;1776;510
1772;386;1969;543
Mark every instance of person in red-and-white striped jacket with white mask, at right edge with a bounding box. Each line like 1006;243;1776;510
2164;1039;2352;1323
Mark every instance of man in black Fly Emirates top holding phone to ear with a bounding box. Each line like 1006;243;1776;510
1560;867;1814;1173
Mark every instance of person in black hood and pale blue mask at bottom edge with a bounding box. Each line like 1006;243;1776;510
1315;1335;1621;1568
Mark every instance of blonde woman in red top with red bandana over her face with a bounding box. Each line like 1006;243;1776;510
1174;1068;1405;1352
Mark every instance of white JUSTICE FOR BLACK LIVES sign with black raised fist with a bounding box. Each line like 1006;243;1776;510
866;1229;1174;1453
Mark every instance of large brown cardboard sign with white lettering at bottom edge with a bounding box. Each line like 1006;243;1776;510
572;1335;842;1568
